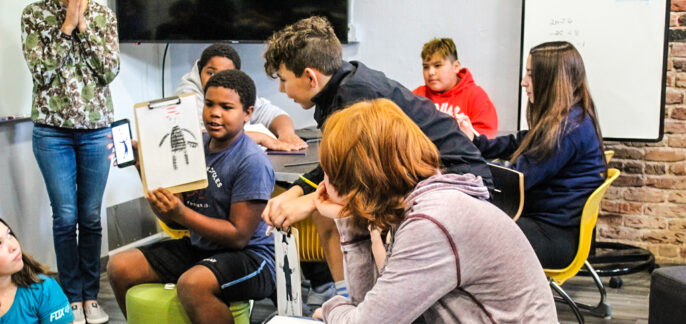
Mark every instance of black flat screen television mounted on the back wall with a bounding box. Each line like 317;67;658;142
115;0;348;43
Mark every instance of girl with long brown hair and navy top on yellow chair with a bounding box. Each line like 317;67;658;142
460;42;607;269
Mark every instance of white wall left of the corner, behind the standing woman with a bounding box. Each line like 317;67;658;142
0;0;169;268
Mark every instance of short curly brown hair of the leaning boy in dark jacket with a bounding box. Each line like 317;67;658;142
264;16;343;79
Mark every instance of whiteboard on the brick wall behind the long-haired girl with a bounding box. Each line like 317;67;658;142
519;0;669;141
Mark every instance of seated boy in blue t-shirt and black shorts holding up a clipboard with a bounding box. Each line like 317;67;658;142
107;70;275;323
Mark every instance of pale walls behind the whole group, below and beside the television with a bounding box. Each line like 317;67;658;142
0;0;521;265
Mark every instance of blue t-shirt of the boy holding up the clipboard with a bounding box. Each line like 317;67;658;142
183;133;274;273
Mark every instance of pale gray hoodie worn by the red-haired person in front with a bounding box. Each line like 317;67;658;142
323;174;557;324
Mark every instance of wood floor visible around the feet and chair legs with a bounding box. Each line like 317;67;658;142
99;272;650;324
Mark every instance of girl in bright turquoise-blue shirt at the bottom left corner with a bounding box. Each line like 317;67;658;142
0;219;74;324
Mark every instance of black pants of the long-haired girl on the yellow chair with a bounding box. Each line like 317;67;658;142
517;216;579;269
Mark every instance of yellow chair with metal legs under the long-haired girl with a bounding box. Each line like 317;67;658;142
544;168;620;323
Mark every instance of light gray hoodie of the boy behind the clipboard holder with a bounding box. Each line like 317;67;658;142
174;61;288;134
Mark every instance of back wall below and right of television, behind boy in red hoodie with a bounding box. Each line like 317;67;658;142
170;0;522;130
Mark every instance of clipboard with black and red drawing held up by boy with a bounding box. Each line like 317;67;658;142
134;93;208;193
